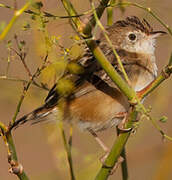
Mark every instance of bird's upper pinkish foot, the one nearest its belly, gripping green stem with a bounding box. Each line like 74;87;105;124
115;112;132;132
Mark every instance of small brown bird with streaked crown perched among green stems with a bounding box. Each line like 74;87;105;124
12;16;165;150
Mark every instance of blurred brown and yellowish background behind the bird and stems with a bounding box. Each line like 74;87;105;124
0;0;172;180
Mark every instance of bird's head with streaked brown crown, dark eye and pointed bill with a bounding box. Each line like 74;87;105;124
101;16;165;54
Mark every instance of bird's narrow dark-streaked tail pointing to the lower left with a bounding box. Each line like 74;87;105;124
10;105;56;129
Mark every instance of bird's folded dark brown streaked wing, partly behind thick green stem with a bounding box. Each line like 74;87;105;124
45;40;123;107
